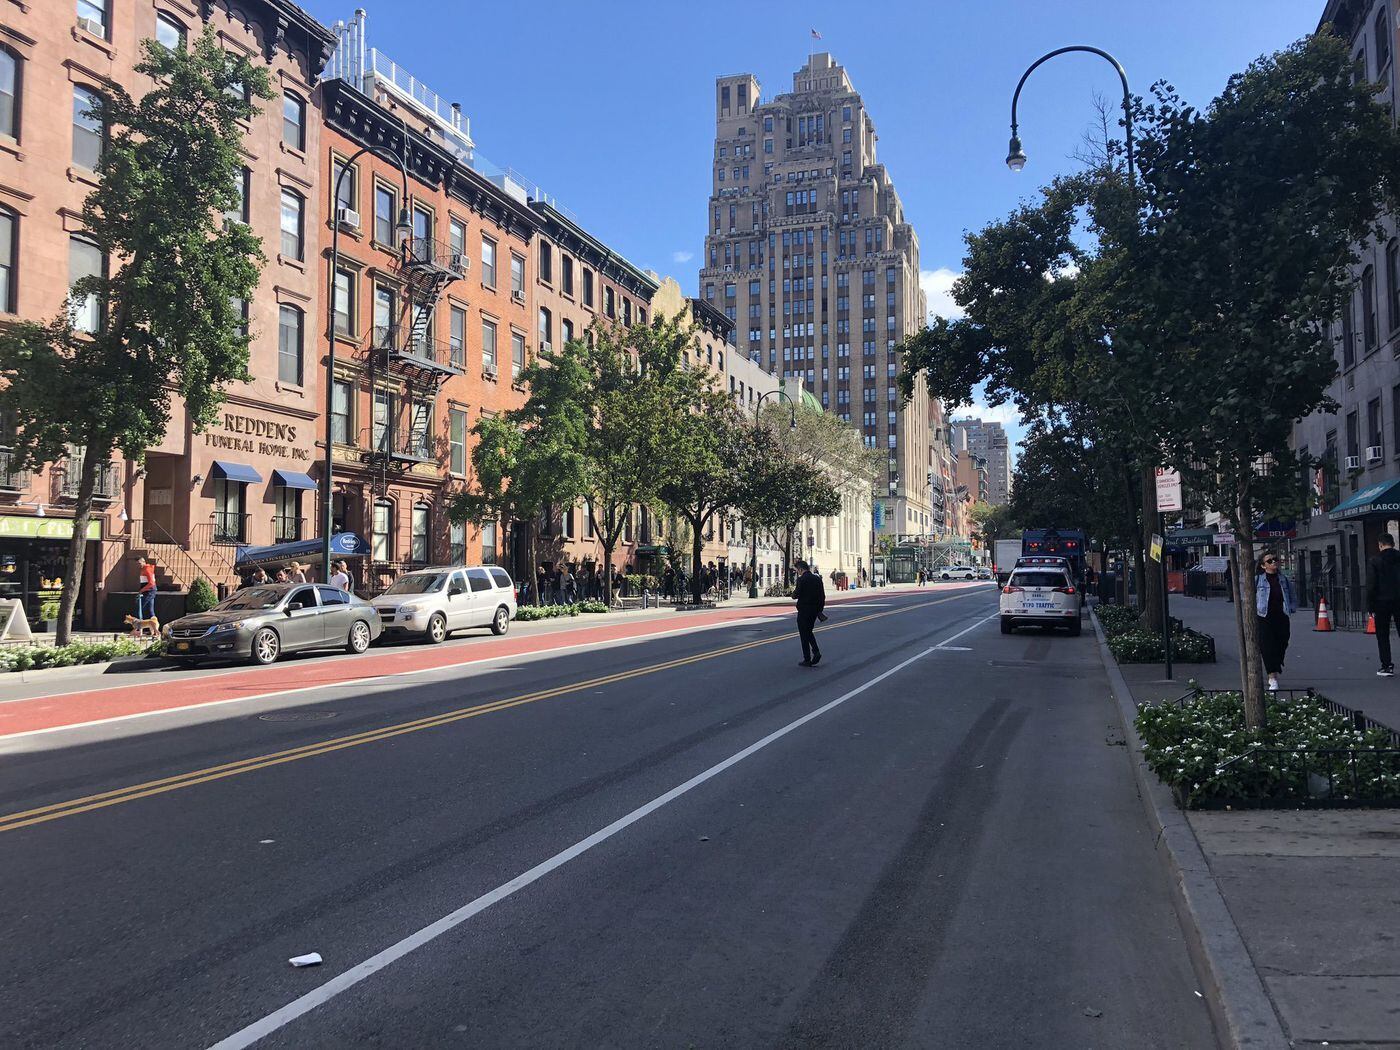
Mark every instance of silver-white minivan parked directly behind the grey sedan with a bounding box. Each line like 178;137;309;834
371;566;515;644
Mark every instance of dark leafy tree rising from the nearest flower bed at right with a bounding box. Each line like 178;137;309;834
1123;31;1400;727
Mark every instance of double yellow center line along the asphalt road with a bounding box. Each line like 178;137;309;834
0;592;972;832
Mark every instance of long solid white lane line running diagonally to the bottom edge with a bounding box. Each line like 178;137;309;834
210;613;998;1050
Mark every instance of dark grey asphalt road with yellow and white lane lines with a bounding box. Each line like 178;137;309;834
0;585;1215;1050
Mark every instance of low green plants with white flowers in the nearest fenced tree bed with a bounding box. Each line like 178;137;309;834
1134;693;1400;808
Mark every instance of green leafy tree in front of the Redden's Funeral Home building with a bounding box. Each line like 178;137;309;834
0;28;272;644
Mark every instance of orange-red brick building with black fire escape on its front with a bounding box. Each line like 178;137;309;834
320;17;540;591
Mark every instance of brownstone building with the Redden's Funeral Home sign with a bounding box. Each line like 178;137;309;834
0;0;332;626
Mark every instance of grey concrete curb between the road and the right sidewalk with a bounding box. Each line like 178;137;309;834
1091;616;1289;1050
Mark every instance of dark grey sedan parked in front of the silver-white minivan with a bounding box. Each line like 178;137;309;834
161;584;382;666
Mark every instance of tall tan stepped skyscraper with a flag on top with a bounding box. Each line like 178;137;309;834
700;52;932;535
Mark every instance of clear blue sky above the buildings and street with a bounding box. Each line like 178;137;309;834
301;0;1323;459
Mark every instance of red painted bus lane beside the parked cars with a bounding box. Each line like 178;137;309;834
0;592;952;738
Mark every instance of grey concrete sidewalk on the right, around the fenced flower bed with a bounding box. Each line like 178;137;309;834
1120;595;1400;1050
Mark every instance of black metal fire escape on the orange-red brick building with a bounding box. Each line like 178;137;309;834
365;235;466;497
